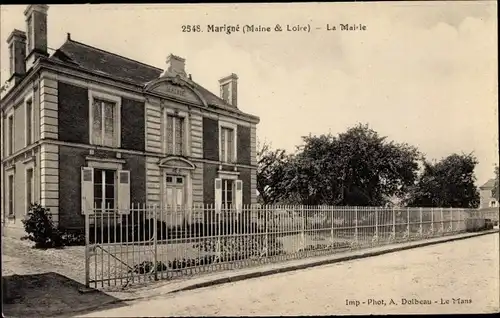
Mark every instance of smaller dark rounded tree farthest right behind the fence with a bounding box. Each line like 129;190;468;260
407;154;479;208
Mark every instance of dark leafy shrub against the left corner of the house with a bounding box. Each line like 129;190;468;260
22;204;64;248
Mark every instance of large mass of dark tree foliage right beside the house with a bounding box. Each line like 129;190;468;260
257;124;421;206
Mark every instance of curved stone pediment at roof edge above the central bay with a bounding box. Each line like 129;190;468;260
146;75;206;106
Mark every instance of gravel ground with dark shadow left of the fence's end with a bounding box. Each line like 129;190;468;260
2;236;119;317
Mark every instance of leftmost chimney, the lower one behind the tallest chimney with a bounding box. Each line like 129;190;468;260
7;29;26;85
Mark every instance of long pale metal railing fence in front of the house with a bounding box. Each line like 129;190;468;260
85;205;490;288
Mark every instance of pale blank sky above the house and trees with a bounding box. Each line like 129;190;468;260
0;1;499;185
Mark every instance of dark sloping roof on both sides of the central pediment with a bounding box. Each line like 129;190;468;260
50;38;252;114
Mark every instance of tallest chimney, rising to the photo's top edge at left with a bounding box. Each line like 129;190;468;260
24;4;49;70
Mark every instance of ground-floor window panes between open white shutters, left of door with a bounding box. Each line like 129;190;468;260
94;169;116;209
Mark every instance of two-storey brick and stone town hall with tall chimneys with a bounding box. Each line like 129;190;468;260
0;5;259;228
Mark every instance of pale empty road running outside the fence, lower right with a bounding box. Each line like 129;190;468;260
79;234;500;317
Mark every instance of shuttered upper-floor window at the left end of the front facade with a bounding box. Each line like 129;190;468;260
89;92;121;147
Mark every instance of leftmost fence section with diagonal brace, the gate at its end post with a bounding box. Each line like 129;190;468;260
85;207;162;288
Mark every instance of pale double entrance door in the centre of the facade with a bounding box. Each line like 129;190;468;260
163;175;186;225
